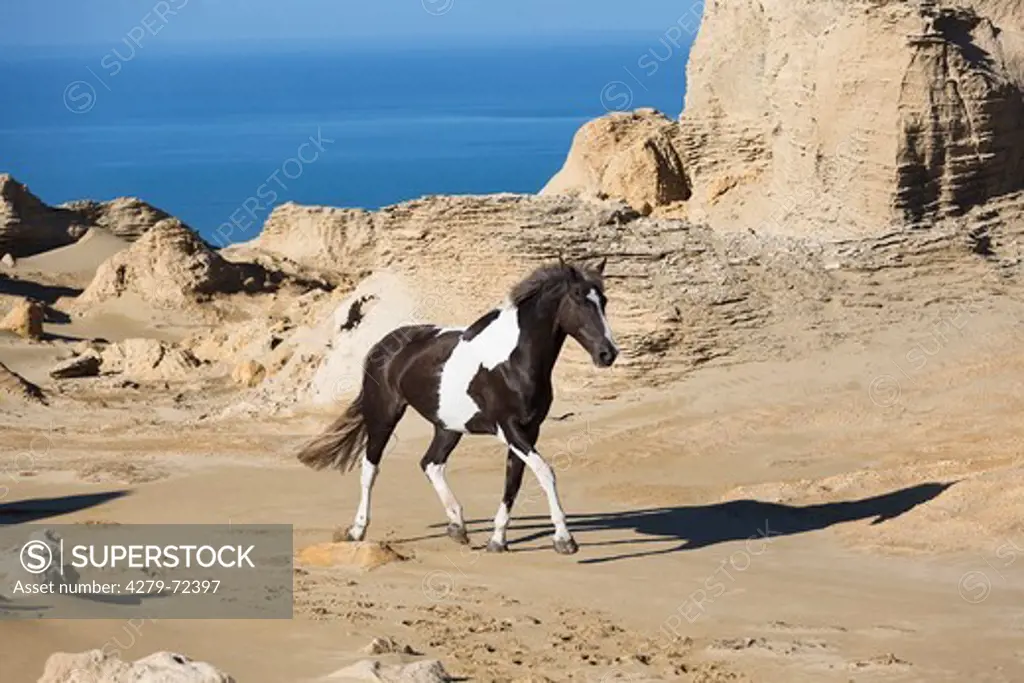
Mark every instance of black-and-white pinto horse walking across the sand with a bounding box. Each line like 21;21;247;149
298;258;618;555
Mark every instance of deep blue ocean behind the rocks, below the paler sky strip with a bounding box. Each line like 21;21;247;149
0;39;687;242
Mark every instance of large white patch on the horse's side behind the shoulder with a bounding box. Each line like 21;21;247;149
437;306;519;432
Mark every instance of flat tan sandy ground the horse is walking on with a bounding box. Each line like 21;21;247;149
0;296;1024;683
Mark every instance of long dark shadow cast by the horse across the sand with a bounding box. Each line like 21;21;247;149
456;482;955;564
